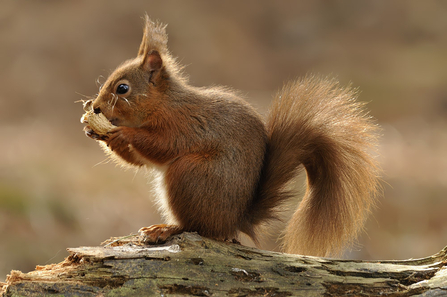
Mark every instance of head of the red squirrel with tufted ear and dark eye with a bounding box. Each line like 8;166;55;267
92;15;178;127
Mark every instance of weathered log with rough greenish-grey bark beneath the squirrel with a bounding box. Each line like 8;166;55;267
0;233;447;296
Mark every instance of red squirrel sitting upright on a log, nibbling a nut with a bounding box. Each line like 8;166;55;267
83;15;379;256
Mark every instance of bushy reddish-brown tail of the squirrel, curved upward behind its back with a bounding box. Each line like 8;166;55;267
253;77;379;256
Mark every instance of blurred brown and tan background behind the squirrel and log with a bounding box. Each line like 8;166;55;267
0;0;447;281
